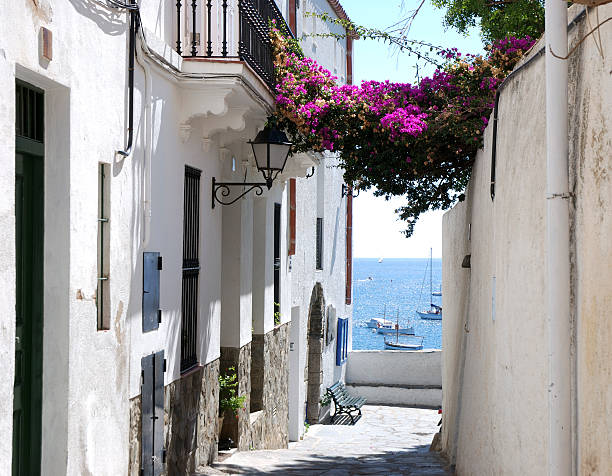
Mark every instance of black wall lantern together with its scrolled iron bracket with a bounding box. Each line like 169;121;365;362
212;126;292;208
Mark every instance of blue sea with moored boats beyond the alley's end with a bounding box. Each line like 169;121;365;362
353;258;442;350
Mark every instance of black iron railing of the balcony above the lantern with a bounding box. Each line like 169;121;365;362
176;0;292;88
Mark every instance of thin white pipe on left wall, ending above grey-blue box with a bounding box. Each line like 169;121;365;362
136;38;153;247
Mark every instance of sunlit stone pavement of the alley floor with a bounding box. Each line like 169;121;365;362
202;405;452;476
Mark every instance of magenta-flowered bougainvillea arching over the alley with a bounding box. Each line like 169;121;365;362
271;28;533;236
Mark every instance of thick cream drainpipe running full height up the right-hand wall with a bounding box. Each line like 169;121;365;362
545;0;572;476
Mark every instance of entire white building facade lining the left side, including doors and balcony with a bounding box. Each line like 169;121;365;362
0;0;352;476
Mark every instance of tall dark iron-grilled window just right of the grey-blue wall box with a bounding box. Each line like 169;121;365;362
181;166;202;371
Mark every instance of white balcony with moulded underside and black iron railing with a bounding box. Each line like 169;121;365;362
160;0;316;180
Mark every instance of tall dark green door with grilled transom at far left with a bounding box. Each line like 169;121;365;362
12;83;44;476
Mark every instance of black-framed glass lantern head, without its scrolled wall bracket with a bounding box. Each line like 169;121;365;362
249;126;291;189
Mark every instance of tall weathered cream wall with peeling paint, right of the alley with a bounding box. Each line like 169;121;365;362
442;6;612;476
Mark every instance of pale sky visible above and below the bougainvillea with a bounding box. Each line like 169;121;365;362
341;0;482;258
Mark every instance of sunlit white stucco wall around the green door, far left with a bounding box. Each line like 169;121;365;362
0;1;131;475
